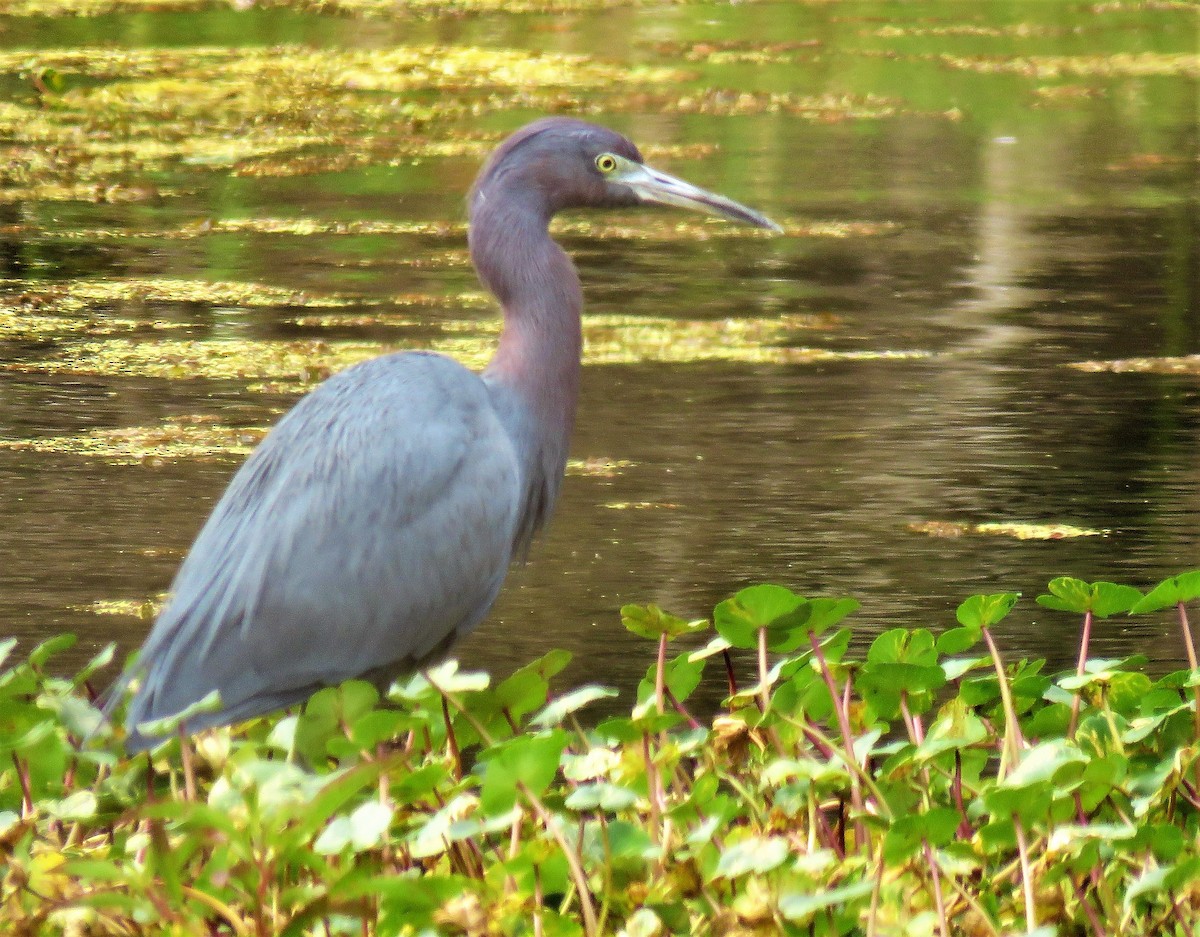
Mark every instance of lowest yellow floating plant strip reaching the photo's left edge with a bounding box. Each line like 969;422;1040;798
0;414;266;466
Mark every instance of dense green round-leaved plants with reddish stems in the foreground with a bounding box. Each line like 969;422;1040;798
0;571;1200;936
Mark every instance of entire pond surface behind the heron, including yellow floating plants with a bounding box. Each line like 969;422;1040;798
0;0;1200;687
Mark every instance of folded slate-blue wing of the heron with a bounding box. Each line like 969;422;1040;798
118;354;521;728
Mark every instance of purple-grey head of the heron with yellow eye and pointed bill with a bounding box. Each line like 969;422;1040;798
470;118;780;230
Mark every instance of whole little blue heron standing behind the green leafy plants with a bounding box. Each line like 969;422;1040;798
112;118;779;751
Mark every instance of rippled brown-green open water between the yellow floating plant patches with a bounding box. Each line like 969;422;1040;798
0;1;1200;700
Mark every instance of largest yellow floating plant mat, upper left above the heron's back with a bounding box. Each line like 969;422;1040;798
0;46;683;202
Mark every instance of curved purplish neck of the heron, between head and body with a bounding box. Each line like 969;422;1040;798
470;193;583;439
